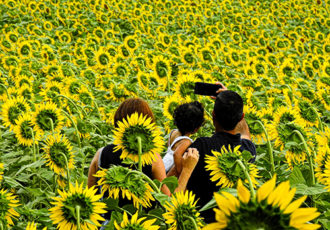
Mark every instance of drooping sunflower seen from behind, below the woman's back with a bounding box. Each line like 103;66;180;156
95;165;155;208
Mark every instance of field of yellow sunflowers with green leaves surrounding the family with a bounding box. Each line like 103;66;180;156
0;0;330;230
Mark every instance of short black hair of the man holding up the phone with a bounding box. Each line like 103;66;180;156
214;90;243;131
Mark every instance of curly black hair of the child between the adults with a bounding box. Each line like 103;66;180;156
173;101;204;135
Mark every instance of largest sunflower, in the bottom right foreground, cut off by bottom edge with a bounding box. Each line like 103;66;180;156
204;176;320;230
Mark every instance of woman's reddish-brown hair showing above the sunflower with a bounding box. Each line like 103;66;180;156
114;98;155;127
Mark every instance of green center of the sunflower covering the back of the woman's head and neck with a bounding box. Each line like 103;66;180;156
123;125;154;154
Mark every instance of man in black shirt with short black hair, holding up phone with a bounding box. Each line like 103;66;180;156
187;83;256;223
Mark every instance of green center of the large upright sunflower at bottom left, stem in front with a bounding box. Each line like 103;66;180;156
62;193;93;223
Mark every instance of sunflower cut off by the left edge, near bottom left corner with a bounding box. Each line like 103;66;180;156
0;189;19;227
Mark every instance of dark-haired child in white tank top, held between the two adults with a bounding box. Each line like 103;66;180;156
163;101;204;176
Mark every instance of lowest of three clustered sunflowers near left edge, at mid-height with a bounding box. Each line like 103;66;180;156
13;113;41;146
